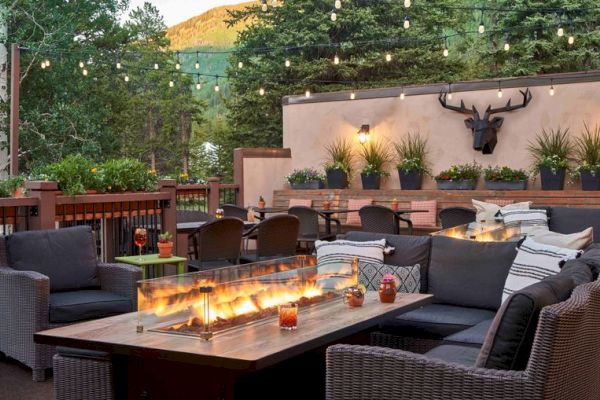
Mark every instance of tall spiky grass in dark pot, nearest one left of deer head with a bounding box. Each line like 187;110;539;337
394;132;429;190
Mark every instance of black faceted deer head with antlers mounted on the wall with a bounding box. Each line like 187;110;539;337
439;89;533;154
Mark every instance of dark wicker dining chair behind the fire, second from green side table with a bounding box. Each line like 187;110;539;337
242;215;300;262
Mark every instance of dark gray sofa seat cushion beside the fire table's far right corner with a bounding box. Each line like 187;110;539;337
383;304;495;339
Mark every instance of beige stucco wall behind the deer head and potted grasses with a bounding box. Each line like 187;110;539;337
283;82;600;189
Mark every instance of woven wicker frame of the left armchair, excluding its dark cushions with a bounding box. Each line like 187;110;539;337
0;228;142;382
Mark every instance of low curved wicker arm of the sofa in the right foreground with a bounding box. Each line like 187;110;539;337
326;345;541;400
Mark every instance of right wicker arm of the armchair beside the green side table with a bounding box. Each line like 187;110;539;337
98;263;142;311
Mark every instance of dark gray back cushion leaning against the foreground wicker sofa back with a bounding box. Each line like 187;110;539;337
475;275;575;370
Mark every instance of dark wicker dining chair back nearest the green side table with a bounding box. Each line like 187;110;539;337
188;217;244;270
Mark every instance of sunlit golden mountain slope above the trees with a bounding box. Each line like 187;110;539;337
167;0;254;50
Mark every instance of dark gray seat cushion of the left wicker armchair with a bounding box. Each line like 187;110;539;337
50;290;133;323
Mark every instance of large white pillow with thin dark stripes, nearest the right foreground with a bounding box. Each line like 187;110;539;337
502;237;581;302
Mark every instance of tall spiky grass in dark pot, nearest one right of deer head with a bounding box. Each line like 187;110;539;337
529;128;573;190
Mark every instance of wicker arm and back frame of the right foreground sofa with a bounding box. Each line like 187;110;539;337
326;281;600;400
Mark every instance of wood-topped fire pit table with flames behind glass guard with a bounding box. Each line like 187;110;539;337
35;256;432;399
